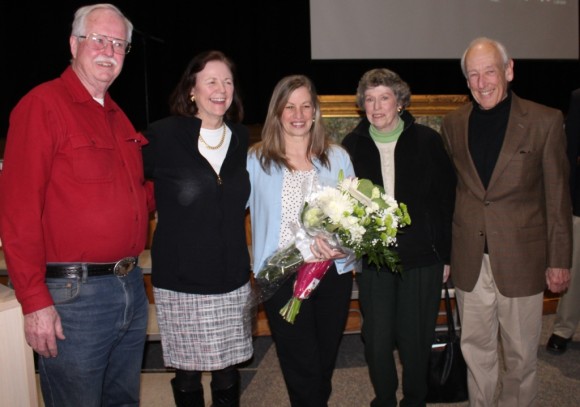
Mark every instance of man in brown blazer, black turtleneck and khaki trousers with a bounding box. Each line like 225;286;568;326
442;38;572;407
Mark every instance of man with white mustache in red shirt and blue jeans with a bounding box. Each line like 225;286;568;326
0;4;148;407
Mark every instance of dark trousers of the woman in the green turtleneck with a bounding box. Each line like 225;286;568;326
357;264;443;407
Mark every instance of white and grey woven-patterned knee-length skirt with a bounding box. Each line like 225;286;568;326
153;282;253;371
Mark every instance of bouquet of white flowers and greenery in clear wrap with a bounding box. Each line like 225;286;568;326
256;172;411;323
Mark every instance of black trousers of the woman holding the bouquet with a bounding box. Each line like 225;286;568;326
264;265;353;407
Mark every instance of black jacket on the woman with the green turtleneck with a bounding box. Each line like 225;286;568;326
342;111;455;269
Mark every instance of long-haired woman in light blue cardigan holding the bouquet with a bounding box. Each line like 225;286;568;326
248;75;353;407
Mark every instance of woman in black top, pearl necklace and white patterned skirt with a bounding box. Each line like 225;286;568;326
143;51;253;407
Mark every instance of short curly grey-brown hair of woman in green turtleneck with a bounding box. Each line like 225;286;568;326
356;68;411;110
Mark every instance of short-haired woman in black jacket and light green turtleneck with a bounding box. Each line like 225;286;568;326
343;69;455;407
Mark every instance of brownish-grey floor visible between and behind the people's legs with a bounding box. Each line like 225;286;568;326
38;315;580;407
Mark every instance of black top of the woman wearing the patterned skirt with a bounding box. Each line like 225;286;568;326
143;116;250;294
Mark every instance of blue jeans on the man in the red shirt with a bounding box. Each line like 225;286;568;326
38;268;148;407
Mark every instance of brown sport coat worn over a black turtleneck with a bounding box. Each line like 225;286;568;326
441;93;572;297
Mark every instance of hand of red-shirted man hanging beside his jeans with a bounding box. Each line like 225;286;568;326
24;305;65;357
